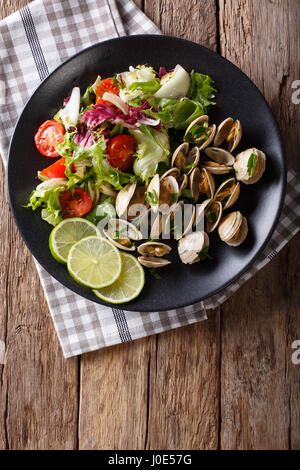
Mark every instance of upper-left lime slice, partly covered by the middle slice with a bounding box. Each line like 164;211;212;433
49;217;100;263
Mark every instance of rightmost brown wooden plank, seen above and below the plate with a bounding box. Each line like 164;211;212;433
220;0;300;449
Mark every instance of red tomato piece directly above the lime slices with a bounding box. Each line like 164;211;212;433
59;188;93;219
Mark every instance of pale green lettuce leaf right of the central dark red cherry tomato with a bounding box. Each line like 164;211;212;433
129;126;170;182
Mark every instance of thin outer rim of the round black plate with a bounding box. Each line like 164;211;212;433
5;34;287;312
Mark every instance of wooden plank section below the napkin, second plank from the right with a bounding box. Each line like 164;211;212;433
147;313;220;450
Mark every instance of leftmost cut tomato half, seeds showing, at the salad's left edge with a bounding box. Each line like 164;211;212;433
34;120;66;157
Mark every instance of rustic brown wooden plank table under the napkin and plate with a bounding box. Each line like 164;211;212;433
0;0;300;449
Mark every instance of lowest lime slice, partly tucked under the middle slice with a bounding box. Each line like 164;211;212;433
93;253;145;304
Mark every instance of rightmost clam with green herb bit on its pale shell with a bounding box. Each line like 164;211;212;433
234;148;266;184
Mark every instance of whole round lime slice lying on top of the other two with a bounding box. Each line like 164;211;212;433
68;237;122;289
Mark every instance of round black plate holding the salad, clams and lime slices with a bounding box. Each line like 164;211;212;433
8;35;286;311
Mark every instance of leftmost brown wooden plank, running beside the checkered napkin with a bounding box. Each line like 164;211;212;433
0;0;78;449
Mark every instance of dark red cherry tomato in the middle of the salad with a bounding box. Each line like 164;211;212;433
107;134;135;170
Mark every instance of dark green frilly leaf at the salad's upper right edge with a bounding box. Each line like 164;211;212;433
187;70;217;113
